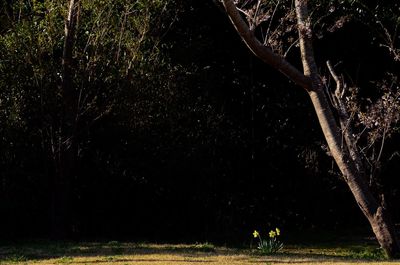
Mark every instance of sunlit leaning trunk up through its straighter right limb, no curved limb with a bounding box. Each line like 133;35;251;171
295;0;400;258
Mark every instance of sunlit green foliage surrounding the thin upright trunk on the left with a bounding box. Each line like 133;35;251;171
0;0;194;236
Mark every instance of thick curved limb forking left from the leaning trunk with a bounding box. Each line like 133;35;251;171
223;0;312;91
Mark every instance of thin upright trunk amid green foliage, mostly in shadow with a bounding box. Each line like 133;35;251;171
52;0;79;238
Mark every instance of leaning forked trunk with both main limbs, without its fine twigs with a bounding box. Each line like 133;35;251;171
222;0;400;258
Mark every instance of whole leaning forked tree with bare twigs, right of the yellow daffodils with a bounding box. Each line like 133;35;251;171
222;0;400;258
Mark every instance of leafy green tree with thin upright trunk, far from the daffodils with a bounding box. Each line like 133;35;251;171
0;0;183;237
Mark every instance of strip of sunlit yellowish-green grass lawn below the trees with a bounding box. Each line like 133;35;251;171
0;241;400;265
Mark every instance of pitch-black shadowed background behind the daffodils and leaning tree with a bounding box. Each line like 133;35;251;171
0;1;400;243
